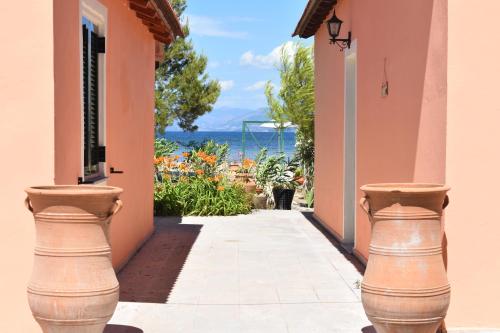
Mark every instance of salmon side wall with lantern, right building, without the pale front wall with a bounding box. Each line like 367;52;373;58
315;0;446;260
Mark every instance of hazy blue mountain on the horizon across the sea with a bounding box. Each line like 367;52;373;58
168;107;269;132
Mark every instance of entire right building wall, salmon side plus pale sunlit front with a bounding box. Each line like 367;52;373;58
315;0;500;330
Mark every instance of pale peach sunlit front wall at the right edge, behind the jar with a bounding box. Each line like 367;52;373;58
446;0;500;330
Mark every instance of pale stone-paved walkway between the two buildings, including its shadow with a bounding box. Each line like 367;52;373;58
105;211;374;333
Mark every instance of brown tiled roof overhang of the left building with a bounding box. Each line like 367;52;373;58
129;0;184;45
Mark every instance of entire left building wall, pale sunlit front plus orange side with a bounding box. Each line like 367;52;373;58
0;0;154;326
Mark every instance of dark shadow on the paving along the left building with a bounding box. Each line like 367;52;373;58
117;217;202;302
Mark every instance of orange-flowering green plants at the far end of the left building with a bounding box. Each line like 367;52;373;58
154;141;251;216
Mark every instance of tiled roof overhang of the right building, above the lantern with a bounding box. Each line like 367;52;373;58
292;0;337;38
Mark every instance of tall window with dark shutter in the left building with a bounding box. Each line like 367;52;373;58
82;16;105;183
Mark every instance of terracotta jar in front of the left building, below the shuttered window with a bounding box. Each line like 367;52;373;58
26;186;122;333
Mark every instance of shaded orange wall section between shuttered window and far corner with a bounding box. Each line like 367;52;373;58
102;0;155;268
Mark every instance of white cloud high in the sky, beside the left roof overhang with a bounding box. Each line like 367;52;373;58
188;15;248;39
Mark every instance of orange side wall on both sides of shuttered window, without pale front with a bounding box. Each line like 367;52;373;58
54;0;155;268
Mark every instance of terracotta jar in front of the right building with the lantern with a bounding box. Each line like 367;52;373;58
361;184;450;333
